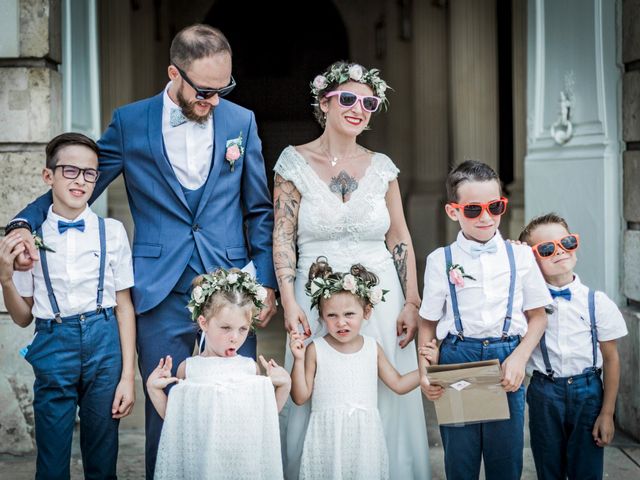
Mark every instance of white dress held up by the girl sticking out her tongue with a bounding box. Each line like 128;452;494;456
154;356;282;480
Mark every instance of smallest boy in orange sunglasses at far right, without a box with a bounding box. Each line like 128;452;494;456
520;213;627;479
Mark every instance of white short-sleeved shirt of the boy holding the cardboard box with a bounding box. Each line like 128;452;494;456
420;232;551;339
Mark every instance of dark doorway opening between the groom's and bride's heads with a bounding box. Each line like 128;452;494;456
204;0;349;181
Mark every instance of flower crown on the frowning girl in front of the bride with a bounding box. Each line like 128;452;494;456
305;257;389;308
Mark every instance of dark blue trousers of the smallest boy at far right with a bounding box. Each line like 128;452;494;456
527;372;604;480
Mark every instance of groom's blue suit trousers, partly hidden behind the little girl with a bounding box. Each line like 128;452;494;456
136;290;256;479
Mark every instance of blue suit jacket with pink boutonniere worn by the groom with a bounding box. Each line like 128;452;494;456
18;93;276;313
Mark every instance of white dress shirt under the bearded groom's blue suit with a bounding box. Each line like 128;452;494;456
162;82;213;190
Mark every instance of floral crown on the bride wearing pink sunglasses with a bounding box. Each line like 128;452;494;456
311;62;391;108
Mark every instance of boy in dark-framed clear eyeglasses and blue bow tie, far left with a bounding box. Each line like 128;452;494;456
0;133;136;478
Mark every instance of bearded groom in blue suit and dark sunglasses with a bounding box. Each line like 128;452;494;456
7;25;276;478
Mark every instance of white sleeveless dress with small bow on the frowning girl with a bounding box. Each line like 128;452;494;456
300;336;389;480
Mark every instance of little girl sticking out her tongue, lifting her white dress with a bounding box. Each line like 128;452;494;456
147;269;291;480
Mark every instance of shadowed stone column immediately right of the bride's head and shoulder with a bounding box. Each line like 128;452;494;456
405;2;449;278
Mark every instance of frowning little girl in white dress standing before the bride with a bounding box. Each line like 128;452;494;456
290;257;437;480
